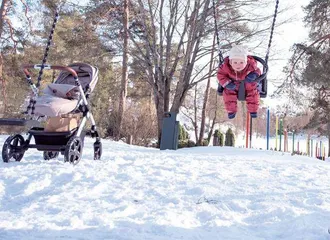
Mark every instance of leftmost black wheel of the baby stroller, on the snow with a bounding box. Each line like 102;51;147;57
2;134;25;162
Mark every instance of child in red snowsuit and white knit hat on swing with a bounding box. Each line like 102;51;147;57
217;45;261;119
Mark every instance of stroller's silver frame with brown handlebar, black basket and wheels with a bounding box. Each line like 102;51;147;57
0;64;102;164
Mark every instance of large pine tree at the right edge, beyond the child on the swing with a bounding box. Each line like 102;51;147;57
284;0;330;154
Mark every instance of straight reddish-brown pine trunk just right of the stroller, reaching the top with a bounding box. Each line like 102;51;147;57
115;0;129;140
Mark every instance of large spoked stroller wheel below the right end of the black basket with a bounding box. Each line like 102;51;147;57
64;136;83;165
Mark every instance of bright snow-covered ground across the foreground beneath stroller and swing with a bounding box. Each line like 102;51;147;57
0;136;330;240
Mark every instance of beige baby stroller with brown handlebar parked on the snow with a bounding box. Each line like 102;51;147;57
0;63;102;164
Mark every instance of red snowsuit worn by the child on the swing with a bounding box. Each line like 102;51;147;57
217;56;261;113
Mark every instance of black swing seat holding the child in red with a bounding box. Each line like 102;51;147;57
217;56;268;101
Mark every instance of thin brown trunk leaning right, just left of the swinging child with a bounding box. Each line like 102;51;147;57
197;33;216;146
